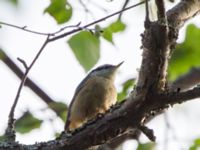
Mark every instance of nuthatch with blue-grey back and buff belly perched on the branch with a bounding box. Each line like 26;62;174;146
65;62;123;131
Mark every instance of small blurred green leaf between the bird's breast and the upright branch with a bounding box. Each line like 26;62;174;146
117;79;135;102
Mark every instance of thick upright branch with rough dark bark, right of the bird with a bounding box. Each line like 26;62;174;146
137;1;170;94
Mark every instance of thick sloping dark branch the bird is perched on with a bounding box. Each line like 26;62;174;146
0;87;200;150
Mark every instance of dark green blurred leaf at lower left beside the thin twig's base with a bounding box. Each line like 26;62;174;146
15;111;42;134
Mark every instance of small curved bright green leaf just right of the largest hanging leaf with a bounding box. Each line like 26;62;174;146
103;20;126;44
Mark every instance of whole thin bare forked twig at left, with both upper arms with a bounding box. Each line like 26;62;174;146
0;2;144;141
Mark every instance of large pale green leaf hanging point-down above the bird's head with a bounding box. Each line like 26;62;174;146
68;31;100;71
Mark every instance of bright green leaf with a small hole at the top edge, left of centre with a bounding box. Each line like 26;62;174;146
44;0;72;24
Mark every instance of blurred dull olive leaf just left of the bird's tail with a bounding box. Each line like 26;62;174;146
49;102;67;121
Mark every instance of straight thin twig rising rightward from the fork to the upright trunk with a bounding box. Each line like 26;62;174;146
49;1;145;42
